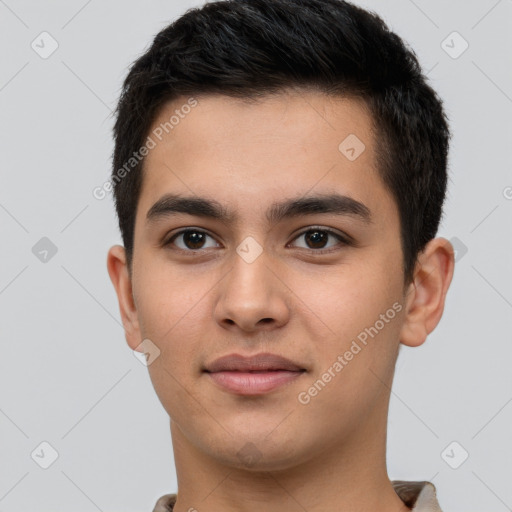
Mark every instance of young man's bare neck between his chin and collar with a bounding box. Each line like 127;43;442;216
171;396;410;512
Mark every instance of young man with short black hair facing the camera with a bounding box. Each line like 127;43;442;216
108;0;454;512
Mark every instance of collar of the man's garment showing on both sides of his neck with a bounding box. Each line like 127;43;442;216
153;480;442;512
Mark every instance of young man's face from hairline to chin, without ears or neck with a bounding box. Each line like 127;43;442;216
113;91;416;469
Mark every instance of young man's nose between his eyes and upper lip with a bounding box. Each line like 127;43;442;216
214;246;290;332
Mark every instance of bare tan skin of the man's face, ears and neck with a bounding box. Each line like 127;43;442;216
107;90;454;512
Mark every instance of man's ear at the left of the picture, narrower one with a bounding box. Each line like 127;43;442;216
107;245;142;350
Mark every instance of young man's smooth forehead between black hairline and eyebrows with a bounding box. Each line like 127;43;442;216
139;91;396;230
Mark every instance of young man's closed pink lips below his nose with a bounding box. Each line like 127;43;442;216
204;353;306;395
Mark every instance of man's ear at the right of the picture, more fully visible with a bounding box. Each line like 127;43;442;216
400;238;455;347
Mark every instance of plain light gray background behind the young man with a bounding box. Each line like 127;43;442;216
0;0;512;512
